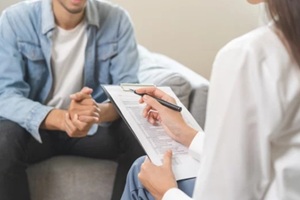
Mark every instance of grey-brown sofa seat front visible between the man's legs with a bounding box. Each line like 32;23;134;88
27;156;117;200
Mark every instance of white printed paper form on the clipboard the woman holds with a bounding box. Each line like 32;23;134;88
102;85;201;180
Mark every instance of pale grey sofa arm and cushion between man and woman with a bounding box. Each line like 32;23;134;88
138;46;209;128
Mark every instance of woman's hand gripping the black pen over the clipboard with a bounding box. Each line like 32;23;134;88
136;87;197;147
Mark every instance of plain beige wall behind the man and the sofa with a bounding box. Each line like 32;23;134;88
0;0;261;78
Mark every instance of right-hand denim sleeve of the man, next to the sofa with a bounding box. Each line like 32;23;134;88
111;11;139;84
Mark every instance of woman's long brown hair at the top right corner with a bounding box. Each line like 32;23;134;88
266;0;300;66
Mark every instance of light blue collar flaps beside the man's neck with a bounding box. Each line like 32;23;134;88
42;0;100;34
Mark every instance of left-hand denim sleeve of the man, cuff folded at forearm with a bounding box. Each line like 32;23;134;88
0;12;52;142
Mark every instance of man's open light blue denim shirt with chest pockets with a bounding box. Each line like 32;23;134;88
0;0;139;142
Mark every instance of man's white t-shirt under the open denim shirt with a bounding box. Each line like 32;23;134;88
47;20;87;109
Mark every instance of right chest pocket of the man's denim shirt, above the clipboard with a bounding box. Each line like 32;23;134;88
96;42;118;84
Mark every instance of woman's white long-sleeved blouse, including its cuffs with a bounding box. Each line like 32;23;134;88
163;26;300;200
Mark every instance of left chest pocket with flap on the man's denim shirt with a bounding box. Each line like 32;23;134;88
18;41;49;92
